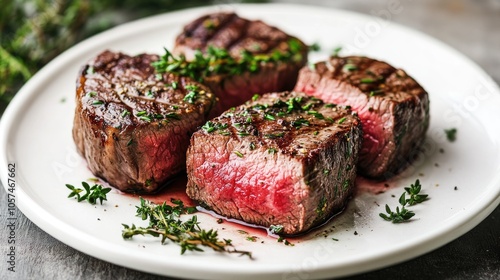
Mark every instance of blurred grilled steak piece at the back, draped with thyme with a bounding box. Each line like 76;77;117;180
174;13;308;113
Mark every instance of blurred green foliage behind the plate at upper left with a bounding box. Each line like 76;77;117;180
0;0;266;114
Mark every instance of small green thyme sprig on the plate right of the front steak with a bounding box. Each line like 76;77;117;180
379;179;428;224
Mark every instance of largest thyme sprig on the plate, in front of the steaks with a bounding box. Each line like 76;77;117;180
122;197;252;258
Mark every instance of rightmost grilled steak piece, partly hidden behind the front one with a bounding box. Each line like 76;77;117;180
295;56;429;179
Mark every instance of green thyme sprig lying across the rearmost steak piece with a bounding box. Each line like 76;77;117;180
152;39;303;82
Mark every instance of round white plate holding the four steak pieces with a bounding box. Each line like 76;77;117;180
0;5;500;279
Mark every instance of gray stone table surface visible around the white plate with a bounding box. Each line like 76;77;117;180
0;0;500;279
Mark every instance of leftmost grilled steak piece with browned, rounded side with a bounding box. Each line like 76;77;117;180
73;51;216;193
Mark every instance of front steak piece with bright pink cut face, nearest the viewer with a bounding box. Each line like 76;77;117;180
187;92;362;234
